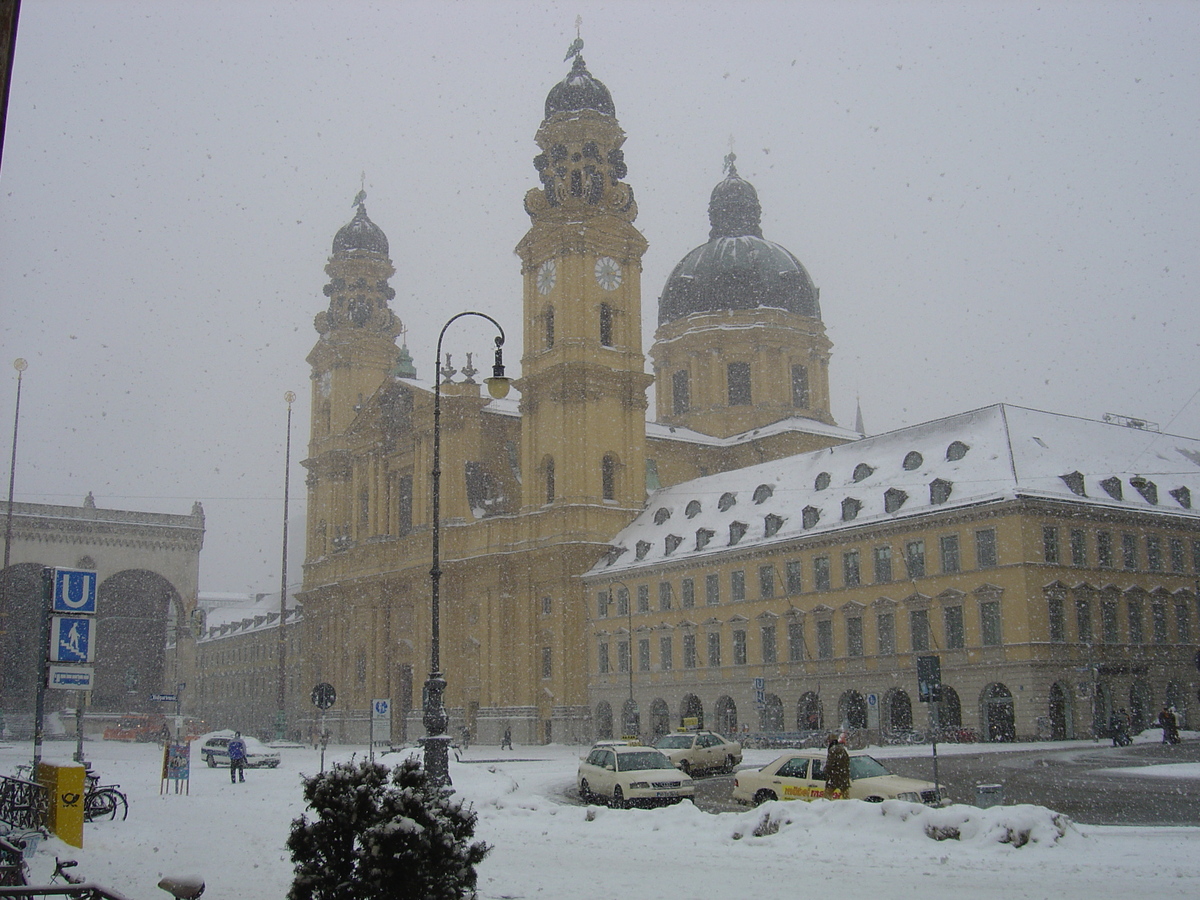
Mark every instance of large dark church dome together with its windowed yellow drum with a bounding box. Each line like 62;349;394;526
650;162;834;438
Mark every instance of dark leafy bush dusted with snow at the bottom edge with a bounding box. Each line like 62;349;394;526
287;760;491;900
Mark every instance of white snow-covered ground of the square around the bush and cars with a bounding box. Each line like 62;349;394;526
0;732;1200;900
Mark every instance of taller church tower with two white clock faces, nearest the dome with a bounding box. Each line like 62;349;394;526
516;51;652;520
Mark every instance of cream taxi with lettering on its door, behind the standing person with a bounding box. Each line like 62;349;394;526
733;750;942;806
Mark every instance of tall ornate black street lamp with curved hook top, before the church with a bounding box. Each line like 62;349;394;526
421;311;510;786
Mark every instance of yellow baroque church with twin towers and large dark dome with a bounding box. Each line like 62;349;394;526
300;55;858;743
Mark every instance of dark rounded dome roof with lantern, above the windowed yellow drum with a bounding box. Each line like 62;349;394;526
659;161;821;325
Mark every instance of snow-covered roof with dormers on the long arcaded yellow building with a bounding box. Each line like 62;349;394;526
590;404;1200;575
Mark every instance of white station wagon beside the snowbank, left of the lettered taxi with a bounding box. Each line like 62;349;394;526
578;745;696;809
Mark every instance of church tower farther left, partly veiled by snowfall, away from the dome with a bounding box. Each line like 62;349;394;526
304;191;401;558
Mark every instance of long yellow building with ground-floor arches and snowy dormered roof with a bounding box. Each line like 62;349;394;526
584;406;1200;740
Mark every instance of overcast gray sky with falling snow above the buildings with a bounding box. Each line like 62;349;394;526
0;0;1200;600
